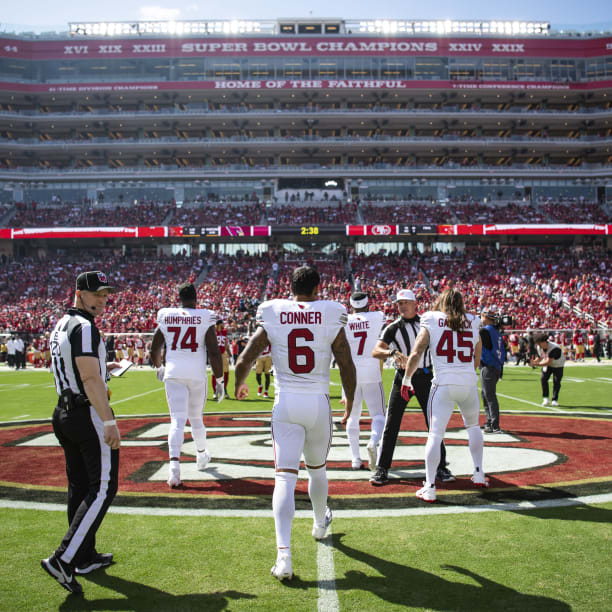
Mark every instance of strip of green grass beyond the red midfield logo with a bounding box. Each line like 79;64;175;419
0;364;612;421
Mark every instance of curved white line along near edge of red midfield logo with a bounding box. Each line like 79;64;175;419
0;493;612;516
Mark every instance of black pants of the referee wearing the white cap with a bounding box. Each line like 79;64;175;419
378;370;446;470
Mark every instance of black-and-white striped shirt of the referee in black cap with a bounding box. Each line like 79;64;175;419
50;308;106;395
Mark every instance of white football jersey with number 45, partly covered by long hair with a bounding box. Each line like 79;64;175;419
421;311;480;385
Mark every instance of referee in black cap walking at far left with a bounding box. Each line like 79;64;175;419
40;271;121;594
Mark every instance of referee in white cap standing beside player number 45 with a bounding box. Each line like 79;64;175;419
370;289;455;486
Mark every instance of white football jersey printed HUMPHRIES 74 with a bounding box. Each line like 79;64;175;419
157;308;216;380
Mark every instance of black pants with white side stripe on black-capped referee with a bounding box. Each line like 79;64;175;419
53;406;119;566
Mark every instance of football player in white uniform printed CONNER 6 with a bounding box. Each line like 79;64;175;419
235;266;356;580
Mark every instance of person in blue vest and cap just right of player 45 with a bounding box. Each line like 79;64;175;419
480;310;506;433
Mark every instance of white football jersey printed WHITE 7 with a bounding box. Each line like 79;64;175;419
345;311;386;384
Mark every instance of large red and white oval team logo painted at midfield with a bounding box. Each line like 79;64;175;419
0;413;612;508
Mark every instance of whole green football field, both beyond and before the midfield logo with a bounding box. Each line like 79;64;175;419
0;364;612;612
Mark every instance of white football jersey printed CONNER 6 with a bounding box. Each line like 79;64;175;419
257;299;346;393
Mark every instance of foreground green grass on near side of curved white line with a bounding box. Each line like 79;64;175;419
0;504;612;612
